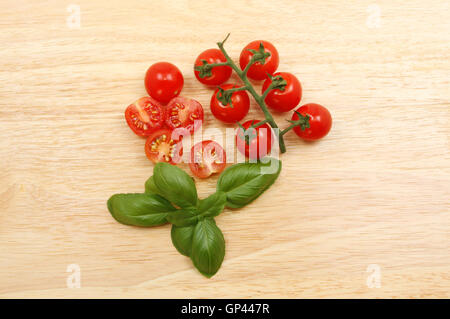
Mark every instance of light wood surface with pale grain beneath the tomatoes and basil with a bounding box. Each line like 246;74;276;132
0;0;450;298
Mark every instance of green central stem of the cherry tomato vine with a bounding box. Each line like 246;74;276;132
217;34;286;153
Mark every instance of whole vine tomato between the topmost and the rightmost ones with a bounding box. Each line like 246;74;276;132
262;72;302;112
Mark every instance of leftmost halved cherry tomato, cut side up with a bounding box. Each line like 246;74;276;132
125;97;165;137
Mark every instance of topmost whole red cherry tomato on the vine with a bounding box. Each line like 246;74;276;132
239;40;279;81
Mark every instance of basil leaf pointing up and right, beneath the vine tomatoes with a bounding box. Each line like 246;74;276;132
217;158;281;208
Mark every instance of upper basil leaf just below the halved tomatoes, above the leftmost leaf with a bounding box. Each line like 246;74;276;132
153;163;197;208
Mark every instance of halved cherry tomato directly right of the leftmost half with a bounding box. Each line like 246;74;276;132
166;96;203;133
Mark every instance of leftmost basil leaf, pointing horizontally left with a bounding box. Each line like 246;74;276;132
107;194;176;227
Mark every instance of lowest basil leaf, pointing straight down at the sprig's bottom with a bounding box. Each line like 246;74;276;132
191;218;225;278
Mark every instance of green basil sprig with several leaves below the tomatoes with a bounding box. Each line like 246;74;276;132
107;159;281;278
